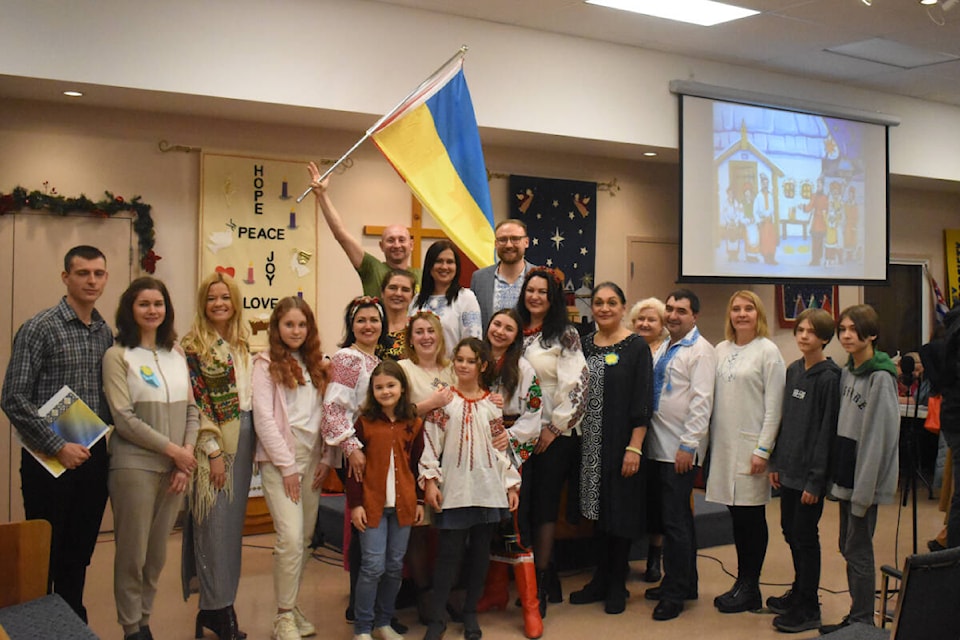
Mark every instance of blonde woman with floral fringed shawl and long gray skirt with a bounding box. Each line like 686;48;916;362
181;273;254;640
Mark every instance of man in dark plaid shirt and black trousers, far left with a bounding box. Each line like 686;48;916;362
0;245;113;622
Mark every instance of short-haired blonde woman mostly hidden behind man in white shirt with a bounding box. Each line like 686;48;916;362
630;298;670;582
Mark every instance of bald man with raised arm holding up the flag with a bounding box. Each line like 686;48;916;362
308;162;421;296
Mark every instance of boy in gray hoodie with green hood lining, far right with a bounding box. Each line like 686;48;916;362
820;304;900;633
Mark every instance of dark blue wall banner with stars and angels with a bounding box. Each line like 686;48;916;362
510;176;597;298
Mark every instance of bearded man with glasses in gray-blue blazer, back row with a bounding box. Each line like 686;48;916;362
470;218;535;331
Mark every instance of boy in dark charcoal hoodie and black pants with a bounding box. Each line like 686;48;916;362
767;309;840;633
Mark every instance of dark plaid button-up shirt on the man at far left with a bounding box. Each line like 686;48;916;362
0;296;113;456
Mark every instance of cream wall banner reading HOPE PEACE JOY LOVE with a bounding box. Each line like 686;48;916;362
199;153;317;350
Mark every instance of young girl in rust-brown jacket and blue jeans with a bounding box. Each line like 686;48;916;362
346;360;423;640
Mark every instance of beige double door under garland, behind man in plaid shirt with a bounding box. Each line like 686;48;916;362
0;213;136;530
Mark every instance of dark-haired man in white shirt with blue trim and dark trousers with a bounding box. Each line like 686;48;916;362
645;289;717;620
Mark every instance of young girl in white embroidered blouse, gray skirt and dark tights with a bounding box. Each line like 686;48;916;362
420;338;520;640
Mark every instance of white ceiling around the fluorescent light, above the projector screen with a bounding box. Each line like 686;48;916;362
377;0;960;106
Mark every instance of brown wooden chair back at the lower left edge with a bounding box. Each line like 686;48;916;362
0;520;53;607
